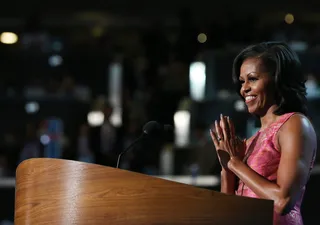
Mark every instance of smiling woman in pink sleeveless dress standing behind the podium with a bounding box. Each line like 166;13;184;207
211;42;317;225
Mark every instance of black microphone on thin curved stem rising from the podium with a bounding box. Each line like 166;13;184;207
116;121;173;168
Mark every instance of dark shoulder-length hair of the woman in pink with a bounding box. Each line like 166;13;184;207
232;42;308;115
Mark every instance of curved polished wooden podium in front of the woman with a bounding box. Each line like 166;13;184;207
14;158;273;225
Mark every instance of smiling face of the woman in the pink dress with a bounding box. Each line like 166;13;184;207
239;58;275;116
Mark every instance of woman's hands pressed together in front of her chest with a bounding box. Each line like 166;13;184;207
210;114;246;169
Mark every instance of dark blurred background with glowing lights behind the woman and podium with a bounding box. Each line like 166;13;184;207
0;0;320;224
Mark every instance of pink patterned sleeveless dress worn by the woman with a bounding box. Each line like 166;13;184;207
235;113;315;225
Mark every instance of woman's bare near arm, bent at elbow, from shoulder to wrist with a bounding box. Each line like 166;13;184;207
228;115;316;214
